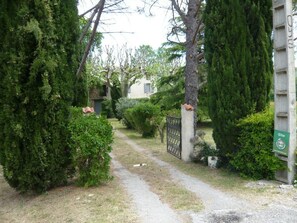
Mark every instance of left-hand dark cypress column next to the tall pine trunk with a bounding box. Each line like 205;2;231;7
205;0;253;158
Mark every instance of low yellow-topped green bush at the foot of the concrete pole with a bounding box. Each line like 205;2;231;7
230;111;284;179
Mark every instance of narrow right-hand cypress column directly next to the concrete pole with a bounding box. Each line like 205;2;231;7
244;0;273;112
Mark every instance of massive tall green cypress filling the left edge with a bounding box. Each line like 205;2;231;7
0;0;79;192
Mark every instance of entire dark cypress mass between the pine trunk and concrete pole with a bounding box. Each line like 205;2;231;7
204;0;272;162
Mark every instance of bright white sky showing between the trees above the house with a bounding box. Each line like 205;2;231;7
78;0;171;49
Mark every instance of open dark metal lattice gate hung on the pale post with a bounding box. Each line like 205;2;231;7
166;116;182;159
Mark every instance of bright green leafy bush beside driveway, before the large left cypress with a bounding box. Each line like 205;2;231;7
68;110;113;187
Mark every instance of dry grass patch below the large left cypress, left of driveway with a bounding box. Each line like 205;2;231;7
0;166;139;223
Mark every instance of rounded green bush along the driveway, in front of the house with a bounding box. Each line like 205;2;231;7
125;102;161;137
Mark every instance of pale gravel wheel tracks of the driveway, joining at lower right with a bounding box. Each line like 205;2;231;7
114;131;297;223
